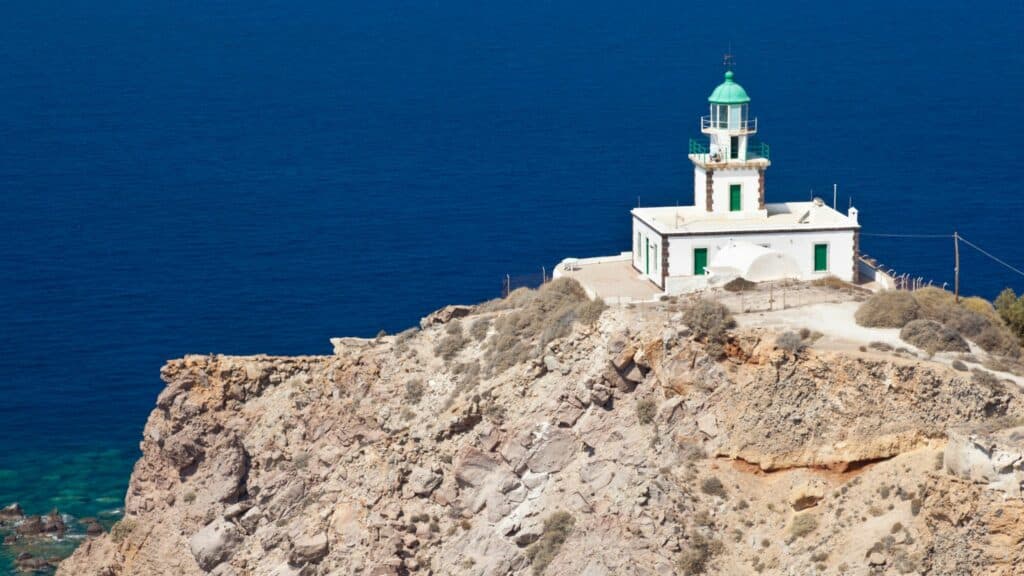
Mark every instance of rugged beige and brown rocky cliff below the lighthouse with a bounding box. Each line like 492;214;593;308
58;282;1024;576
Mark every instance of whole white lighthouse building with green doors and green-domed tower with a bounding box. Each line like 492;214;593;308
632;71;860;293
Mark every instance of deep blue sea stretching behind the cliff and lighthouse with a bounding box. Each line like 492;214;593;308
0;0;1024;569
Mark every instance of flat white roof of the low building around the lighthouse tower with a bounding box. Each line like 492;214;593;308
632;201;860;235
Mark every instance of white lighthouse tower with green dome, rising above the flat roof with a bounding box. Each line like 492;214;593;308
689;70;771;218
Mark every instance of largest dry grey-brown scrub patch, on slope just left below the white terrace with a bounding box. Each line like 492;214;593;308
482;278;607;373
